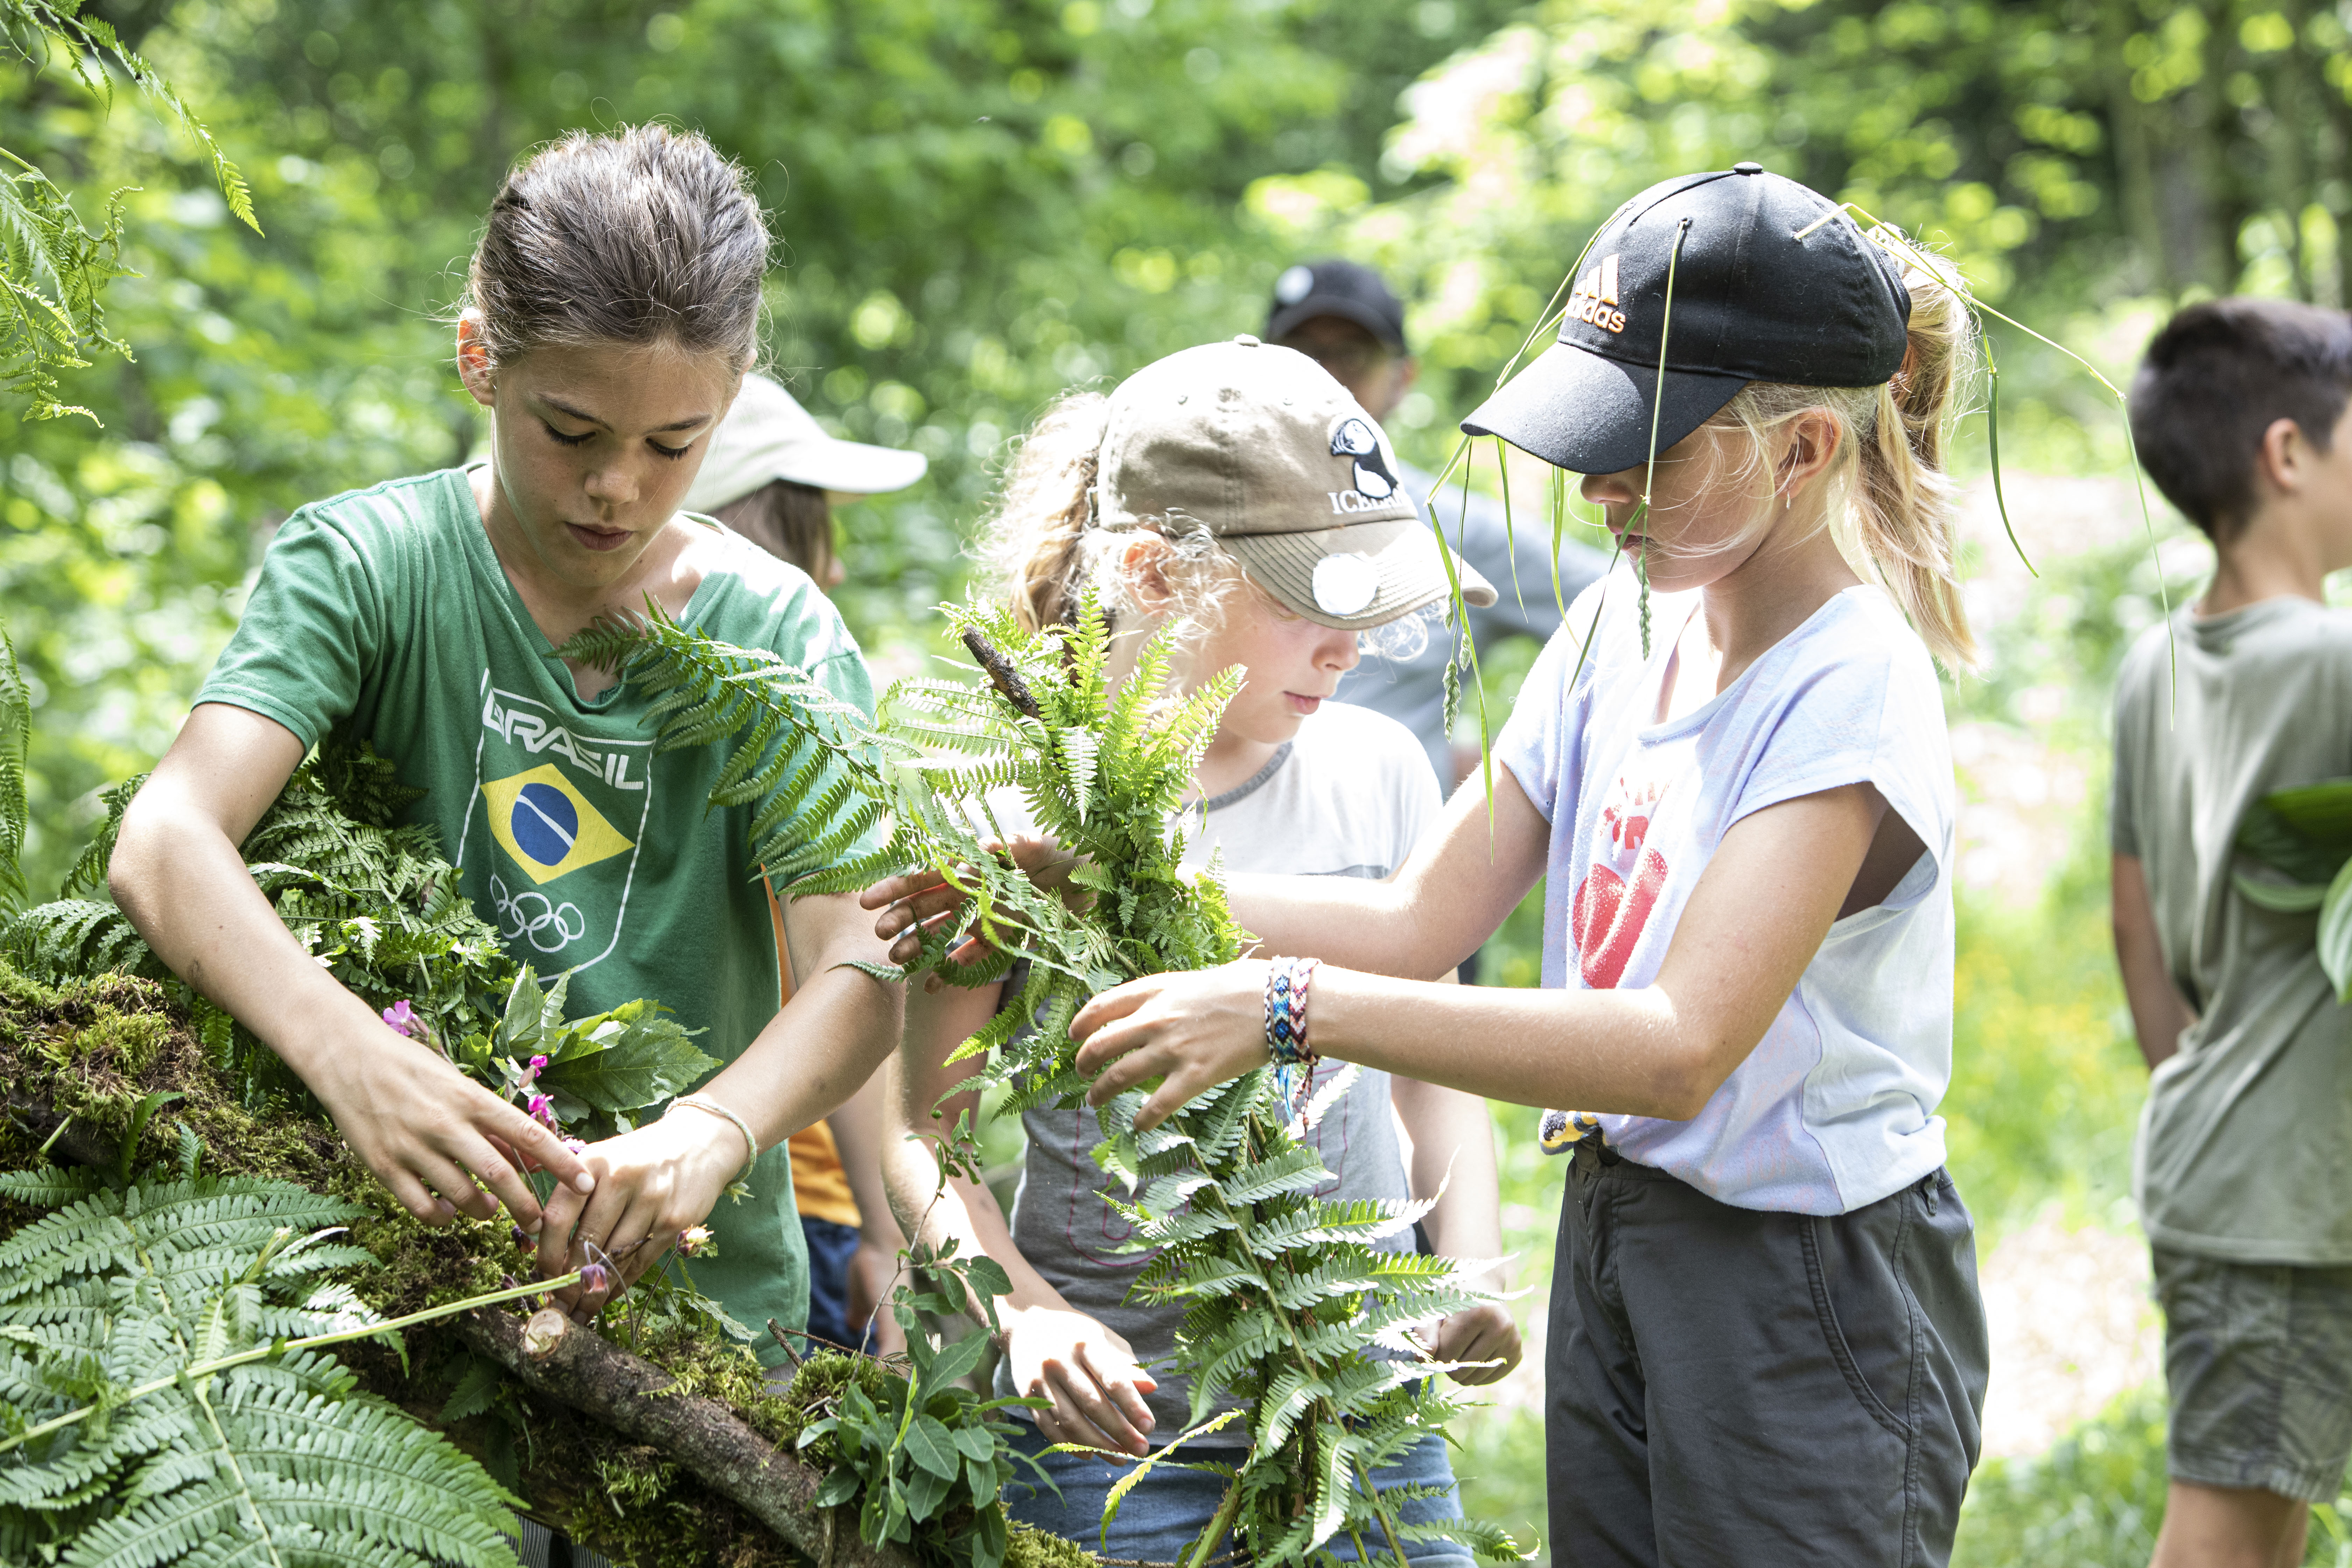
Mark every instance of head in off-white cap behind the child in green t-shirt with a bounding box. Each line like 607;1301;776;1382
685;374;931;590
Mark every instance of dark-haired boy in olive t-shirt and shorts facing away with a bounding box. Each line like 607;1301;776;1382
2112;299;2352;1566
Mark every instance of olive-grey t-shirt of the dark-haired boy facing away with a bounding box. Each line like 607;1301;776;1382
2112;600;2352;1265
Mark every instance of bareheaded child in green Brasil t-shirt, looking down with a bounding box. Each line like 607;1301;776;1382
111;127;901;1326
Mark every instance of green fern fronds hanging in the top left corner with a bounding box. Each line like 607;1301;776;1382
0;0;261;423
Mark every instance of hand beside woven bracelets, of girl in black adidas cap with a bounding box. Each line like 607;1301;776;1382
1070;959;1270;1133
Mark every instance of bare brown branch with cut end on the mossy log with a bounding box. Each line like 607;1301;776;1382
454;1307;917;1568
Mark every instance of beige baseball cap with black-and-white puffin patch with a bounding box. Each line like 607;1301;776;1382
1096;334;1493;630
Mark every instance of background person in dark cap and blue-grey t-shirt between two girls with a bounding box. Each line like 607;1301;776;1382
1263;259;1609;804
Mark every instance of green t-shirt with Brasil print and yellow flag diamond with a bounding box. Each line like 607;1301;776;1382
195;470;873;1359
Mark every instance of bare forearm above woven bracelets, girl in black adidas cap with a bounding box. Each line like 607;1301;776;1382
1308;966;1703;1124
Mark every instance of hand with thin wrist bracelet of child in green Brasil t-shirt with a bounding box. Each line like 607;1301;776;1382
539;1112;743;1323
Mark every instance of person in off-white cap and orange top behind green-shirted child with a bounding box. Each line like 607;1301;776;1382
685;374;929;1354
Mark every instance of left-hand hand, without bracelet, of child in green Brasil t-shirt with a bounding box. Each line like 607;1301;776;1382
306;1029;595;1234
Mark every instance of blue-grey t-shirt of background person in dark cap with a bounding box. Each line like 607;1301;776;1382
1338;468;1609;792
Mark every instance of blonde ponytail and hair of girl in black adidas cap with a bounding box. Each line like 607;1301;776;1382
1712;247;1983;670
